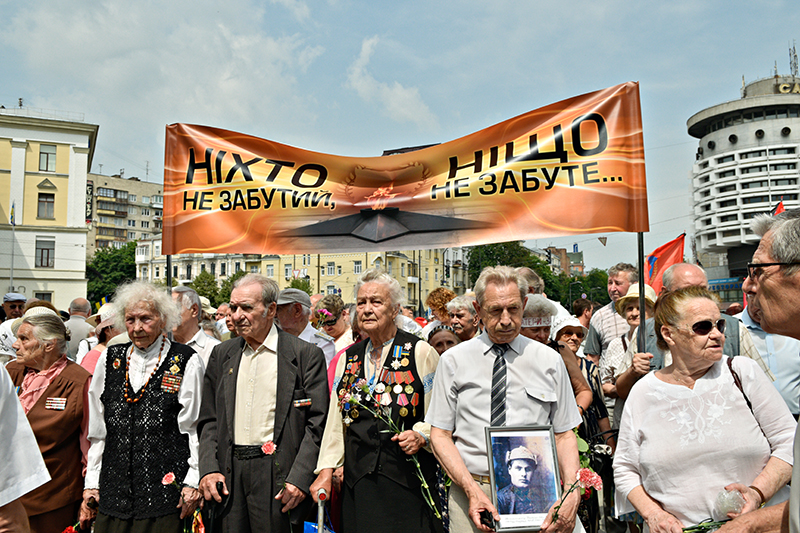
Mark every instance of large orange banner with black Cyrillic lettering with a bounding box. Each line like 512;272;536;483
163;82;648;254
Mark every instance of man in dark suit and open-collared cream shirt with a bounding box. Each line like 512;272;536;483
198;274;328;533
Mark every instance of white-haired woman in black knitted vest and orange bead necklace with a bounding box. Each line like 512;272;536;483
81;282;204;533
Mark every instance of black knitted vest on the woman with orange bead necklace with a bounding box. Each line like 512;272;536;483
100;341;195;520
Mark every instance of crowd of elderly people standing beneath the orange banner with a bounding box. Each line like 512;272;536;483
0;211;800;533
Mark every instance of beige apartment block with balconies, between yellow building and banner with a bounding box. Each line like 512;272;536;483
86;174;164;257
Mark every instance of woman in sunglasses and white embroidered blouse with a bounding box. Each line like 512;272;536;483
614;287;796;533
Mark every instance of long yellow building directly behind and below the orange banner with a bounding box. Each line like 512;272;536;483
136;237;468;309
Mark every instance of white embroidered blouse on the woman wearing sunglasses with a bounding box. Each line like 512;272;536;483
614;356;797;527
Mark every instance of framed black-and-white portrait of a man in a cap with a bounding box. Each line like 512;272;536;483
486;426;561;532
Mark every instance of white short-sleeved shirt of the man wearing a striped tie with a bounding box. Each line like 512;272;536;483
425;331;581;475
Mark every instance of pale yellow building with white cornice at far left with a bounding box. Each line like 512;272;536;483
0;107;98;309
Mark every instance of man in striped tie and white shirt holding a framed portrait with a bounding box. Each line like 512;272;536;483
425;267;581;533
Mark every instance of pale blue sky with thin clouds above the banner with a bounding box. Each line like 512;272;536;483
0;0;800;268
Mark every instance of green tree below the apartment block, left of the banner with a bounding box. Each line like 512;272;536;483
86;241;136;303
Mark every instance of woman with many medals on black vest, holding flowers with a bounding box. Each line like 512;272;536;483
311;269;442;533
